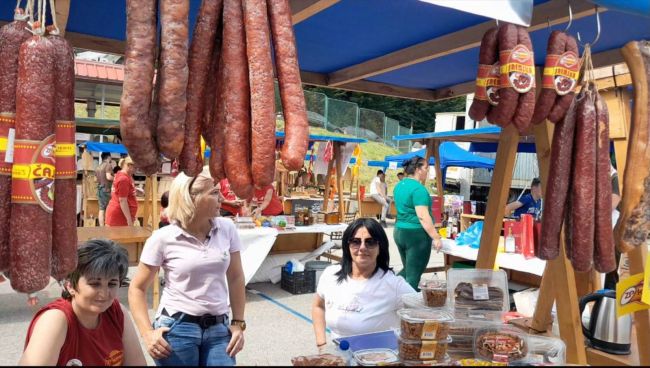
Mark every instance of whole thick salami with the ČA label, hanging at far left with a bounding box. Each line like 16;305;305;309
9;35;55;293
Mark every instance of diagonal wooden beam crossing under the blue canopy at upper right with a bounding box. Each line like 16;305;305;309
329;0;605;87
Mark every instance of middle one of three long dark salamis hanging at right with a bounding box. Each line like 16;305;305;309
571;83;596;272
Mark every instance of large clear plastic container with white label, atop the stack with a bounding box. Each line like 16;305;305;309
447;269;510;312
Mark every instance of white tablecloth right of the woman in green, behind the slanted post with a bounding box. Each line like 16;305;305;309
442;239;546;276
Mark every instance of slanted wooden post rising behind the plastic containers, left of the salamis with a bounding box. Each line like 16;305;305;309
476;124;519;270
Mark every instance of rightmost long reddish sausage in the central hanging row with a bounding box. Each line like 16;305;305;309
268;0;309;170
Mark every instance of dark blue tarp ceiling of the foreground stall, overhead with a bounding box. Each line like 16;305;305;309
0;0;650;97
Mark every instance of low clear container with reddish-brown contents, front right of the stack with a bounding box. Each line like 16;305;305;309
474;326;529;363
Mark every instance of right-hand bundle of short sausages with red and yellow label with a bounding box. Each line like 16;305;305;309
532;31;580;124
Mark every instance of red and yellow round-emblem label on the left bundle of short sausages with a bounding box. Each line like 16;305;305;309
499;45;535;93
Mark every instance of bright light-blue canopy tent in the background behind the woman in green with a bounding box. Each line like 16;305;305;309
385;142;494;170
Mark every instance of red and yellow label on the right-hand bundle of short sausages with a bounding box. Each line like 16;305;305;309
542;51;580;96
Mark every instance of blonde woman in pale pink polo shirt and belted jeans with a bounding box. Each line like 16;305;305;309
129;166;246;366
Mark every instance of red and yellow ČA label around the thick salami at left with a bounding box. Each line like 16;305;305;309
11;134;55;213
